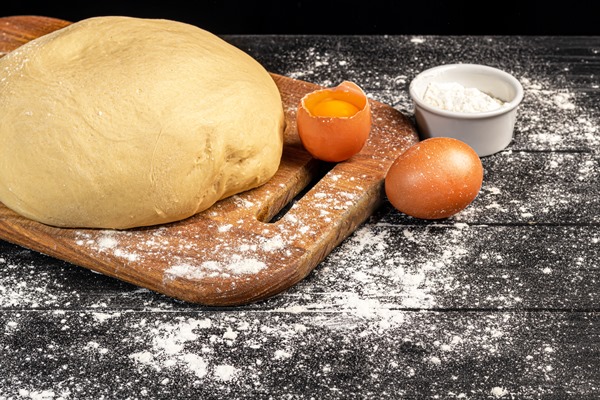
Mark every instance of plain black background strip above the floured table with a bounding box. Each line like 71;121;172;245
0;0;600;35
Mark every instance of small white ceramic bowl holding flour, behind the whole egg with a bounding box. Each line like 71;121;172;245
409;64;523;157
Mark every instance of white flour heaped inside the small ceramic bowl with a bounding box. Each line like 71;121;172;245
423;82;504;113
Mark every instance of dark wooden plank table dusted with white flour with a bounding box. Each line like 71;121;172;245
0;30;600;400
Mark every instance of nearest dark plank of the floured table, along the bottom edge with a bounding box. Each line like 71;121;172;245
0;310;600;400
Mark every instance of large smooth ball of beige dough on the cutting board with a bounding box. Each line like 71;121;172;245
0;16;284;229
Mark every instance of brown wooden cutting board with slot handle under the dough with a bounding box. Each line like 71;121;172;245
0;16;418;306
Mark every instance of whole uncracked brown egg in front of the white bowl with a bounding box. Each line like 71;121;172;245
385;137;483;219
